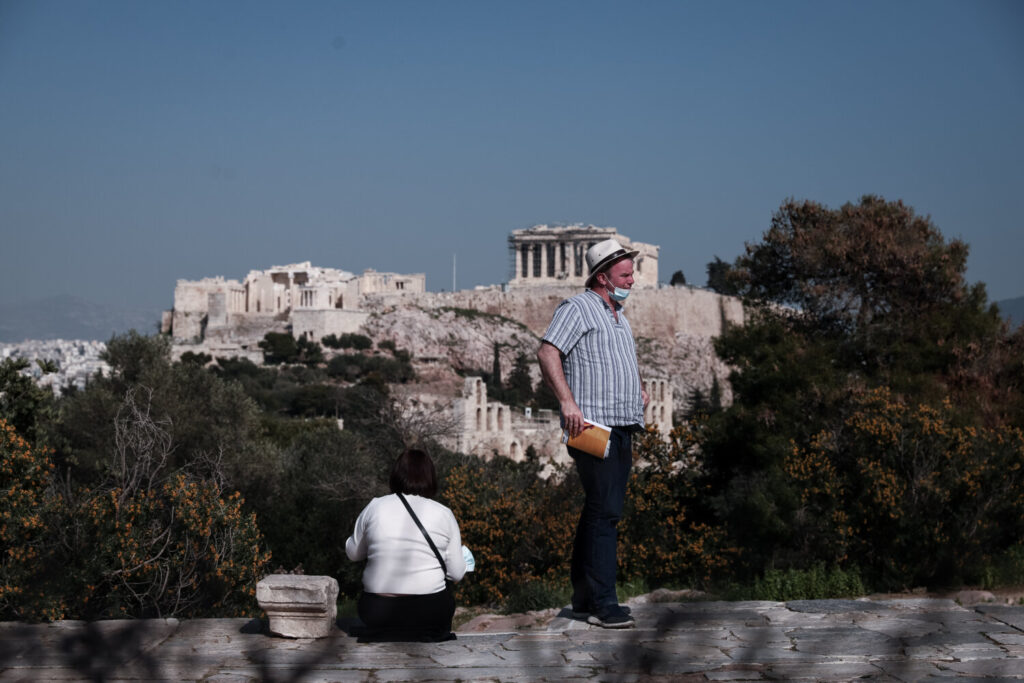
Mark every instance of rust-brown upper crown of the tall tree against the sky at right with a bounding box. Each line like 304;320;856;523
737;197;1005;411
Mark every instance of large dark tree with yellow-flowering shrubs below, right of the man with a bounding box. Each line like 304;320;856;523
695;197;1024;586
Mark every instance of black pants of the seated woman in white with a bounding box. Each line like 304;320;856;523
358;590;455;640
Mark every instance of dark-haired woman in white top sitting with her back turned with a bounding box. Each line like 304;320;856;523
345;450;466;640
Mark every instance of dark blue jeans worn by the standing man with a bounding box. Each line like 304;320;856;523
568;427;633;612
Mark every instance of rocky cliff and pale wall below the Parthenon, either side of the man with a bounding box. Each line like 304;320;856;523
364;287;743;411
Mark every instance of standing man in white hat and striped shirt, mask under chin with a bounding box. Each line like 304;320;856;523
537;240;647;629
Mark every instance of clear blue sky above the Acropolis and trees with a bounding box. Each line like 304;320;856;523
0;0;1024;310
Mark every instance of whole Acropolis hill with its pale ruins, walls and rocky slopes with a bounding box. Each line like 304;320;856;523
163;225;743;464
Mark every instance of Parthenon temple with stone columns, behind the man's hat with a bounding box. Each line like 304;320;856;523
509;223;659;288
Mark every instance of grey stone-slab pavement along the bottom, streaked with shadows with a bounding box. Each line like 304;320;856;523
0;598;1024;683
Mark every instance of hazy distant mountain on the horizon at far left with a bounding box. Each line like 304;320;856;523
0;295;160;342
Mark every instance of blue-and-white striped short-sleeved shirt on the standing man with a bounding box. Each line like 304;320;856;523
544;290;643;427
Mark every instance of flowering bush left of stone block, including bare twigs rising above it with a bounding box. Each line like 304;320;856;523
62;392;269;618
